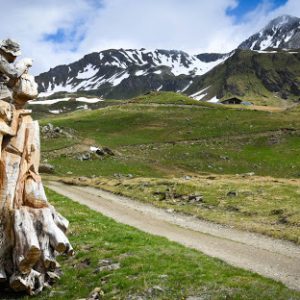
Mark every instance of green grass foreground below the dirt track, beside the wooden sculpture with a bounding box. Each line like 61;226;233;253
12;191;300;300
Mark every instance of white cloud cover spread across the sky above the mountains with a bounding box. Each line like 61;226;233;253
0;0;300;73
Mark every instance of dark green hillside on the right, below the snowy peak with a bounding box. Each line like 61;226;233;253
186;49;300;106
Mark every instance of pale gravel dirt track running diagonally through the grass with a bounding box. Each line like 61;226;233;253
46;182;300;290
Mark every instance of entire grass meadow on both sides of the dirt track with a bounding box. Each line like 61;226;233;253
24;92;300;300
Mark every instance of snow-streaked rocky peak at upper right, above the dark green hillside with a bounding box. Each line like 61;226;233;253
238;15;300;50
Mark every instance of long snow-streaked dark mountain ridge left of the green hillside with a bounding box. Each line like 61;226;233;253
36;49;229;98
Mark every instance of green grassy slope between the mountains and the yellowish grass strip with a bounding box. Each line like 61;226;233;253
42;92;300;177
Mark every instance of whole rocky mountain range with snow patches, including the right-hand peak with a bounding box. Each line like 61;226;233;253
36;16;300;102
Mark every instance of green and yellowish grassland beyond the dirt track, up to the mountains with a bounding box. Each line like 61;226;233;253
42;93;300;243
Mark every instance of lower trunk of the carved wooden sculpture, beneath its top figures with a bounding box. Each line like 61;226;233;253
0;106;73;295
